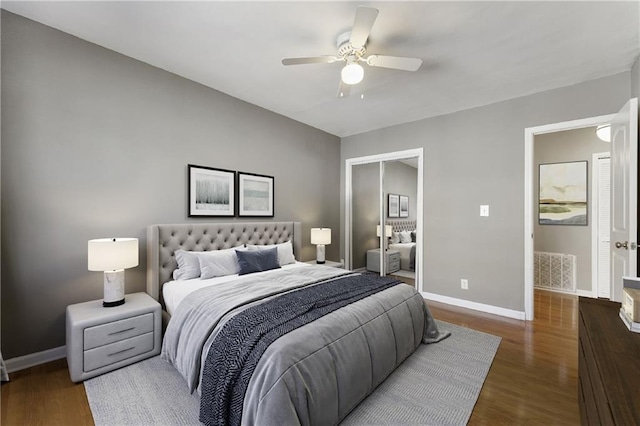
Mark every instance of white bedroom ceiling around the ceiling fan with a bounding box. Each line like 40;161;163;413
2;1;640;136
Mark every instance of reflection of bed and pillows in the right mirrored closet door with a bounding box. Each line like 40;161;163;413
386;219;416;285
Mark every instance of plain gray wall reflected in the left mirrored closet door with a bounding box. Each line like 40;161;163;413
351;163;380;270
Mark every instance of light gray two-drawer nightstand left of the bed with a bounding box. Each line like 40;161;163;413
67;293;162;382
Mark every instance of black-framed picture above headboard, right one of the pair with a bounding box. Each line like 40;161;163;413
238;172;274;217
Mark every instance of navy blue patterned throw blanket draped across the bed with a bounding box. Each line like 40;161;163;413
200;274;400;426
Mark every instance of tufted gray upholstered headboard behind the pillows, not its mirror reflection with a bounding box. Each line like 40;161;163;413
147;222;302;309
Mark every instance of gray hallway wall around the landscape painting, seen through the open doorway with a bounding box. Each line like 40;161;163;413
533;127;611;291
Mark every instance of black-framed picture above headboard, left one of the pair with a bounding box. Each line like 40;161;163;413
188;164;236;217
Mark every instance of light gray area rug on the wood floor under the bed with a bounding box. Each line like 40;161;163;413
84;321;501;426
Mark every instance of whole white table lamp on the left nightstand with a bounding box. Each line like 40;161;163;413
88;238;138;308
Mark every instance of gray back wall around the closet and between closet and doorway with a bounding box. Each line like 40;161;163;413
341;72;630;311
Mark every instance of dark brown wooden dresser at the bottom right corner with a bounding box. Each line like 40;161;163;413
578;297;640;426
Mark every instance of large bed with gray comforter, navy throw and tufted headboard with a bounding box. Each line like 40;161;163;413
147;222;448;425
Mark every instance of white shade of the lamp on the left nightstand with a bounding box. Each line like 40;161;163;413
88;238;138;271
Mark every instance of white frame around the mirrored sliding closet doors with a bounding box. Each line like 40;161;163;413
344;148;424;292
